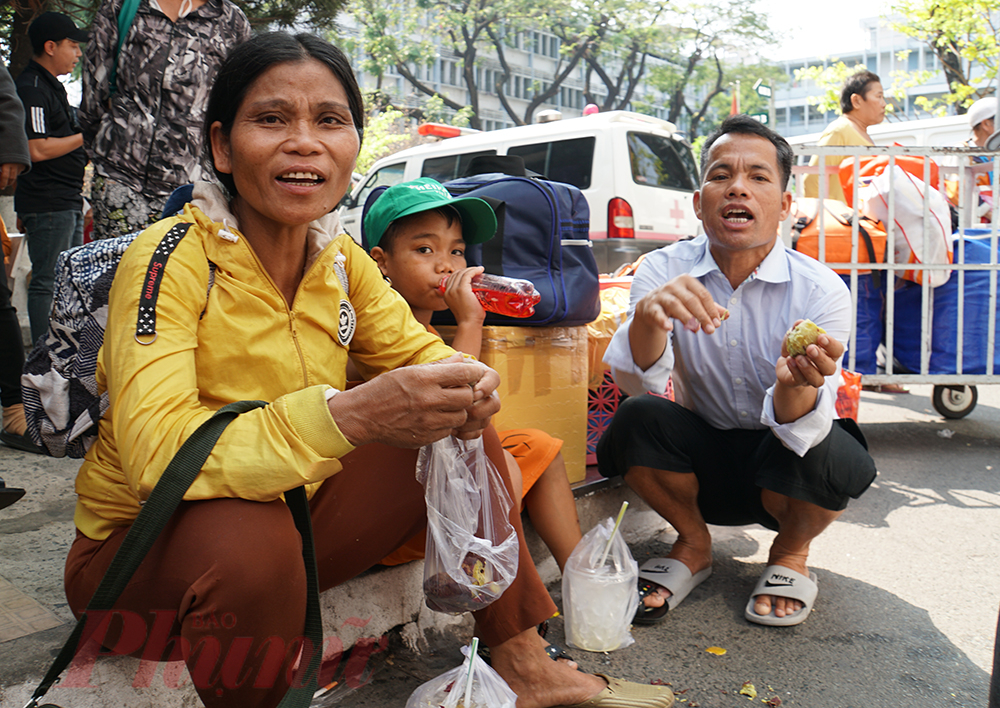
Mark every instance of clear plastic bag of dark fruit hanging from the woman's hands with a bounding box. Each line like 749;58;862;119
417;436;518;613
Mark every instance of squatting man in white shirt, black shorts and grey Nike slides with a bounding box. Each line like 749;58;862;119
597;115;876;625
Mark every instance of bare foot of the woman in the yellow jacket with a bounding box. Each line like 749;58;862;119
490;627;607;708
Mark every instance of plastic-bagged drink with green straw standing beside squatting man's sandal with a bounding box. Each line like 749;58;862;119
562;518;639;651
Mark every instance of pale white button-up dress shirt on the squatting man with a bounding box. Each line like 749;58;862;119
604;235;851;457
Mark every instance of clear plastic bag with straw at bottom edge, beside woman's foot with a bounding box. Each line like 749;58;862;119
406;646;517;708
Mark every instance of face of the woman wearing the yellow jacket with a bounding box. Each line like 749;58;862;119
211;59;360;232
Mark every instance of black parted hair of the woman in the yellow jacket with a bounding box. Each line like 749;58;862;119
202;32;365;194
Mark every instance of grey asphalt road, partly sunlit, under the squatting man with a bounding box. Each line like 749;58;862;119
326;386;1000;708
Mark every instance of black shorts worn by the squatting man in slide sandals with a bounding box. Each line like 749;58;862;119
597;394;876;530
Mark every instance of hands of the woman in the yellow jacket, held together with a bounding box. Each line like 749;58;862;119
329;354;500;448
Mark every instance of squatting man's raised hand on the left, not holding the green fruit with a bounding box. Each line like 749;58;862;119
629;274;727;371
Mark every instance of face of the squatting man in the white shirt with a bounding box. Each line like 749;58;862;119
694;133;792;259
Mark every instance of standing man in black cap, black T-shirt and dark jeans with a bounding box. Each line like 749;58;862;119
14;12;88;340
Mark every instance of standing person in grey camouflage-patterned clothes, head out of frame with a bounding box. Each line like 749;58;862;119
79;0;250;238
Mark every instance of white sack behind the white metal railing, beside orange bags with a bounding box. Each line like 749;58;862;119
859;165;952;288
